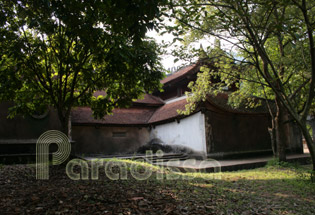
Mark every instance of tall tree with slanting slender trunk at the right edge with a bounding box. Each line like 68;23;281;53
172;0;315;170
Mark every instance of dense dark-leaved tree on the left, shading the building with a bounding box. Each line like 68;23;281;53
0;0;165;137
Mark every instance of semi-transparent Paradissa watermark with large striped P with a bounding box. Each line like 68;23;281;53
36;130;221;180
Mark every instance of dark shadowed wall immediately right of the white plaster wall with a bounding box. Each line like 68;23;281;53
206;111;271;153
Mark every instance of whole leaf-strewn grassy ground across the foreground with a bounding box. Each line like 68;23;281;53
0;159;315;215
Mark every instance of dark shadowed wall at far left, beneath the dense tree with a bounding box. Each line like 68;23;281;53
0;103;60;139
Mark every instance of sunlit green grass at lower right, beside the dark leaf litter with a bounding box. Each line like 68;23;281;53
107;161;315;215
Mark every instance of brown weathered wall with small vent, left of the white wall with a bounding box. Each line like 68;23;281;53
72;126;150;155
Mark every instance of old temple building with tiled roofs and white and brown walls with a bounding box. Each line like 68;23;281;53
0;64;303;161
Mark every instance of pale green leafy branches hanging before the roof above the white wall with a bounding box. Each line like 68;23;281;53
179;40;263;114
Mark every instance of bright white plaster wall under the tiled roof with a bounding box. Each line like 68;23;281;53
150;112;207;154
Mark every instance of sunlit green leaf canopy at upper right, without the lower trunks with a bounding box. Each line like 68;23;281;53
169;0;314;116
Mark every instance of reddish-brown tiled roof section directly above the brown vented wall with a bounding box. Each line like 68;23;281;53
71;107;155;125
